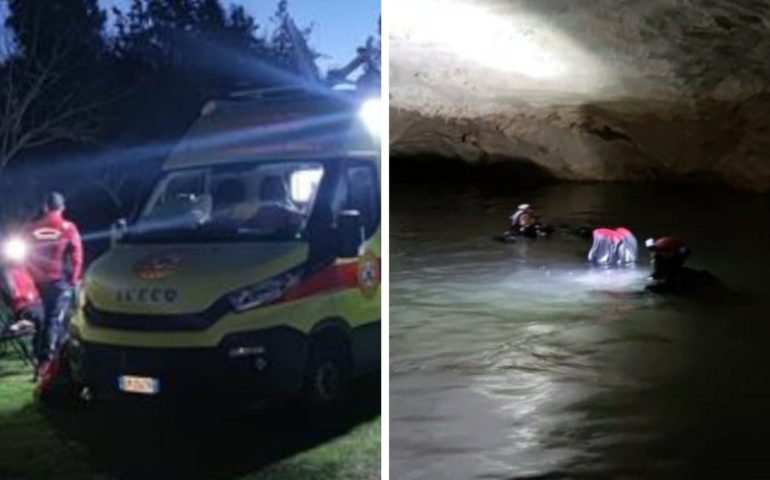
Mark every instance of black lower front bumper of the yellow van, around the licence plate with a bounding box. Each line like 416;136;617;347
69;327;309;401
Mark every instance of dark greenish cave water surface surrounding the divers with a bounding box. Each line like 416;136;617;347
390;186;770;479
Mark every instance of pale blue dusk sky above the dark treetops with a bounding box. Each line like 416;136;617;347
0;0;380;70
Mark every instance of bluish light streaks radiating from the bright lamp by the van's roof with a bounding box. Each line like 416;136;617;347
0;31;378;241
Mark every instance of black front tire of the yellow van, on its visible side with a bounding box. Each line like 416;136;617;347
303;333;351;408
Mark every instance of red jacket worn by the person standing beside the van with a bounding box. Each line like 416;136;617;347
27;211;83;284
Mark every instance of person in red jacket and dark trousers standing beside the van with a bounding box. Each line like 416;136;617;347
26;192;83;368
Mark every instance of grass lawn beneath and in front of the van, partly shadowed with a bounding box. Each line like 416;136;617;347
0;356;380;480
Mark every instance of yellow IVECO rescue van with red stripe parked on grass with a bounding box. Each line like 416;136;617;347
67;89;380;403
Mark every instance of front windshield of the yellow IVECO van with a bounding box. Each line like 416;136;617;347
124;161;324;242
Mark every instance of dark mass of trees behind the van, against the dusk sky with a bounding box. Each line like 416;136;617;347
0;0;318;208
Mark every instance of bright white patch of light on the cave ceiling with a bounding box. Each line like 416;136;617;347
391;0;569;79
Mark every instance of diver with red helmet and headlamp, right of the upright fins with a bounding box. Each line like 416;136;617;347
645;236;720;294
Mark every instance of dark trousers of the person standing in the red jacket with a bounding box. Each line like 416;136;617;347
38;280;75;364
